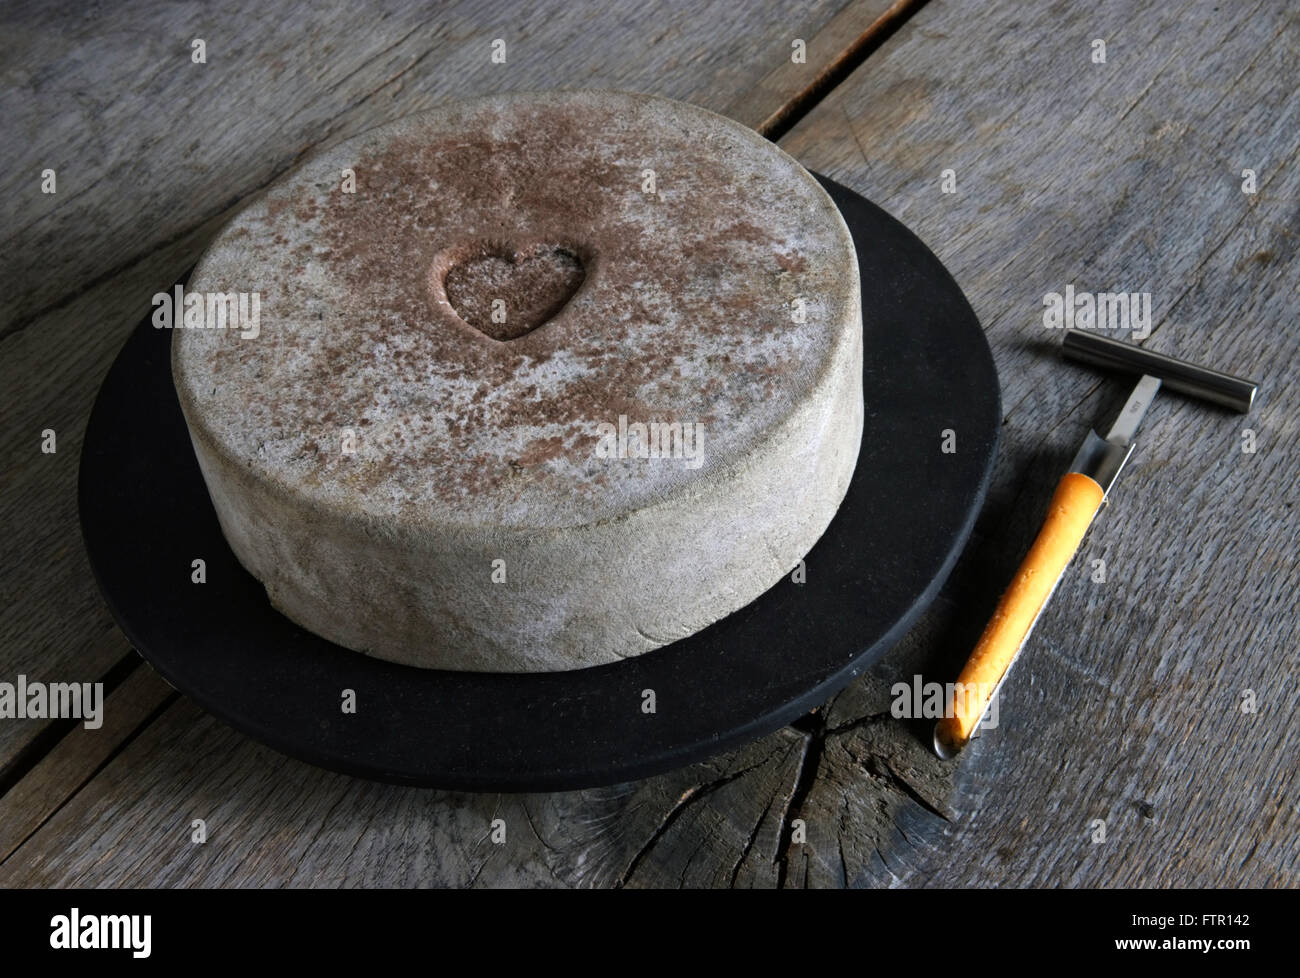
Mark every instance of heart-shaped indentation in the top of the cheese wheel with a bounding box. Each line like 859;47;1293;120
433;242;586;341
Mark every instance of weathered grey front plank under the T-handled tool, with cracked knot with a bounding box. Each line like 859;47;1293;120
0;0;1300;887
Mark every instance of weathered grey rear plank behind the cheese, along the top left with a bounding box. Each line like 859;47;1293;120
0;0;863;334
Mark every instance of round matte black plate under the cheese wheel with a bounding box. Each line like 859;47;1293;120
79;177;1001;791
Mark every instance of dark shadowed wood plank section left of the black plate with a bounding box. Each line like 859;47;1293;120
0;206;239;770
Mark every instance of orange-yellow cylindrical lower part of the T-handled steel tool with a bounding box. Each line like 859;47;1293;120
935;472;1105;749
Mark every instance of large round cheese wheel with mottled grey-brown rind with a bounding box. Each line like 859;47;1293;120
173;92;862;671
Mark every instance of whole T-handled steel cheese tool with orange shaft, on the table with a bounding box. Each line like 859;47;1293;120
935;330;1257;758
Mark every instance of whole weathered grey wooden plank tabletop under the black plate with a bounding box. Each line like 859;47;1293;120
0;0;1300;887
